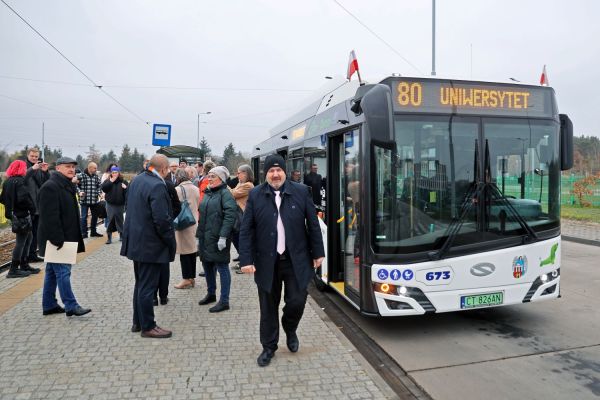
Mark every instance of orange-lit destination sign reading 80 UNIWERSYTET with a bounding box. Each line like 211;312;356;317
387;79;556;117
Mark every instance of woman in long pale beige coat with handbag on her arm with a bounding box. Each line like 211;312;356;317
175;167;200;289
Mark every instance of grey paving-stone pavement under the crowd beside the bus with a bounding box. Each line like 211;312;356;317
0;239;395;399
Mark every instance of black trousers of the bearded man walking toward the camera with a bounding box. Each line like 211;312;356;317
258;259;308;351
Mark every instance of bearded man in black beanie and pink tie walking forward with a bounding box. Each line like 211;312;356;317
240;155;325;367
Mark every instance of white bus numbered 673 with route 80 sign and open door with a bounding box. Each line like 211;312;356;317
252;76;573;316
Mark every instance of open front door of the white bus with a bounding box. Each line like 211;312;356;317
328;130;361;304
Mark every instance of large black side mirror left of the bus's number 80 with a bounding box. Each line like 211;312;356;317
360;84;394;141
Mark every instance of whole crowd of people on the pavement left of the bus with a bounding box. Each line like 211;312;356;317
0;148;325;366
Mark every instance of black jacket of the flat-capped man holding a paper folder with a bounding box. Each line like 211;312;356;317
37;171;85;257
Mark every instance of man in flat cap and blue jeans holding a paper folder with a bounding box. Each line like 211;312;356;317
38;157;92;317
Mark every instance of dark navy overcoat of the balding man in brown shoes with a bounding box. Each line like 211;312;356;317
121;171;176;263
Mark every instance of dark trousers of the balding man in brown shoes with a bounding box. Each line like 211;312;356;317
133;261;162;331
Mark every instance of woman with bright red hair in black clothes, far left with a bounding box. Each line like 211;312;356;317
0;160;40;278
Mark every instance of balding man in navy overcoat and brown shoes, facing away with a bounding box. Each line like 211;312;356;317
121;154;176;338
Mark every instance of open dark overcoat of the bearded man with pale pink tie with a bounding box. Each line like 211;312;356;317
240;181;325;292
